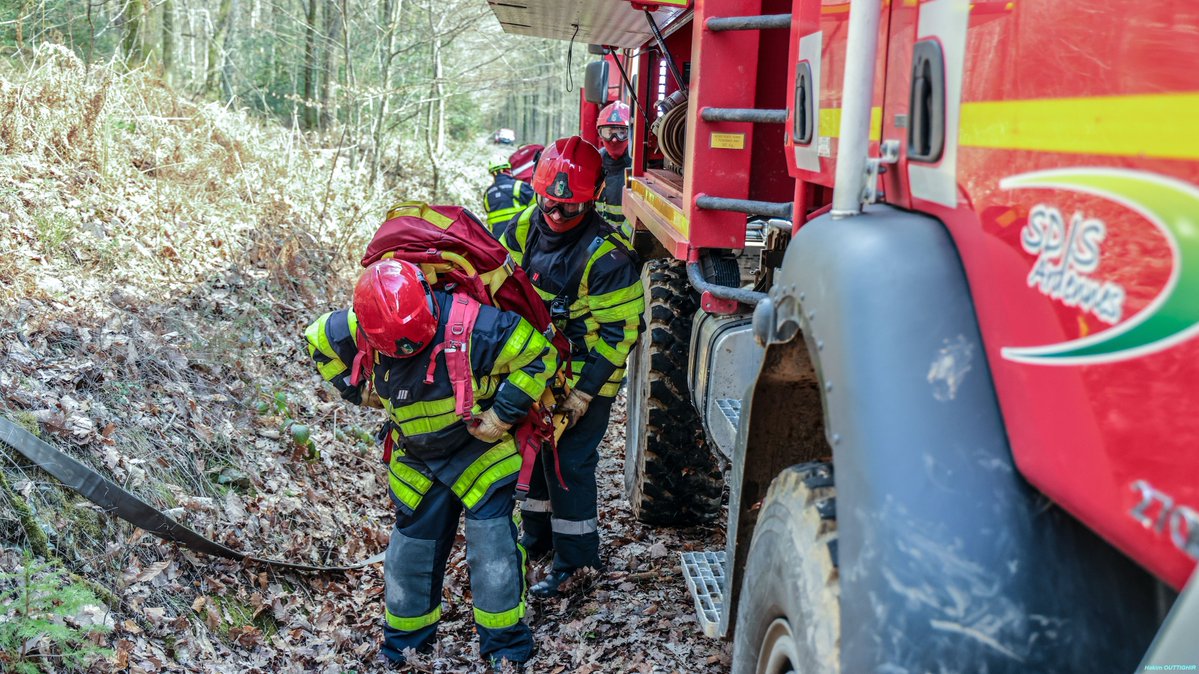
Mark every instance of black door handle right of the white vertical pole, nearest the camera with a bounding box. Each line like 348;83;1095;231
908;40;945;163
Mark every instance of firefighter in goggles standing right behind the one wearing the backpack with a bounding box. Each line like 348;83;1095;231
500;136;645;597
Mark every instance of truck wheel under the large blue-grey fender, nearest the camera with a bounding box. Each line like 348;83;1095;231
733;463;840;674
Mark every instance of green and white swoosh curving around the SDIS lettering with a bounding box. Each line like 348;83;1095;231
999;168;1199;365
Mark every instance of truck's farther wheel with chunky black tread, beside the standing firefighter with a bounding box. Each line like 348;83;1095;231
625;259;723;525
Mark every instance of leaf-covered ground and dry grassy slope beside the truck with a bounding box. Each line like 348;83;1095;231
0;44;727;673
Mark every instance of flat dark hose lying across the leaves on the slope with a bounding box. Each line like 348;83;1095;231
0;416;384;572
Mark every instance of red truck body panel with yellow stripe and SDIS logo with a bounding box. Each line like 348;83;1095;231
882;0;1199;588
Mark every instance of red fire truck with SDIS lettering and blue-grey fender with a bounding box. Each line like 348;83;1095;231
489;0;1199;674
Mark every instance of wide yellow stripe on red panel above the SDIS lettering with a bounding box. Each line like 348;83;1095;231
959;92;1199;160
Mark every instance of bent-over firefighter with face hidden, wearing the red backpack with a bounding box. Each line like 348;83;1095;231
305;259;559;666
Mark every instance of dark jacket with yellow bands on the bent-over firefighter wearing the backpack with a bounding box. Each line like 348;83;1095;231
305;290;559;512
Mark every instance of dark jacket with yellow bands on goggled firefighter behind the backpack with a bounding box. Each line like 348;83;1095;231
500;205;645;397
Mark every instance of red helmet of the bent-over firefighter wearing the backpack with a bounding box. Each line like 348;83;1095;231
354;258;438;359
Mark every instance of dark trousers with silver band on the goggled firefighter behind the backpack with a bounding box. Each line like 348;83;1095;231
520;396;613;571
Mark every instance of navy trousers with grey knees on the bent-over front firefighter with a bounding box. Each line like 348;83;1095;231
382;482;532;663
